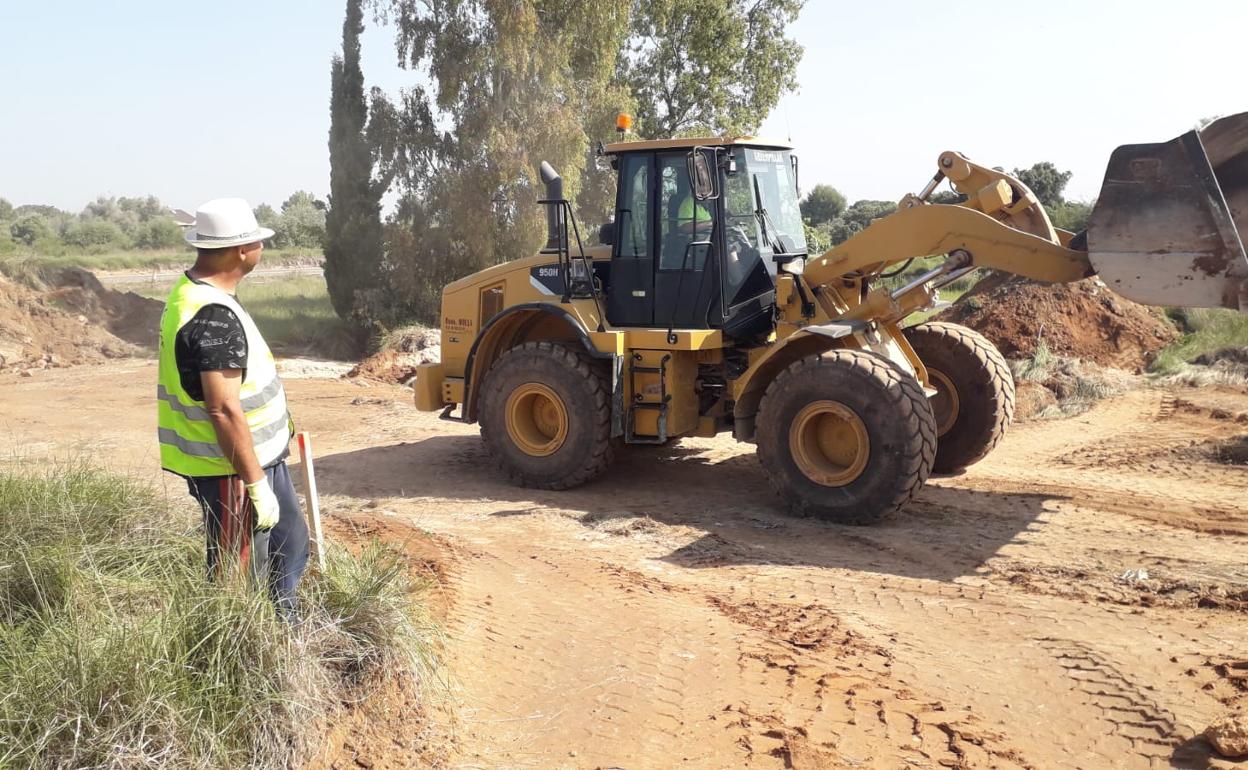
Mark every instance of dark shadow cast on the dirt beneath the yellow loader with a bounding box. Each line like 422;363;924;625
317;436;1058;580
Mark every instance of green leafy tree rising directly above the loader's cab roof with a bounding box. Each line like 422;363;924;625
620;0;805;139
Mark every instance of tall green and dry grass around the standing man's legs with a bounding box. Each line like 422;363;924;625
0;465;431;769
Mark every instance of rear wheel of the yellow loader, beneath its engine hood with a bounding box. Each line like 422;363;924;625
480;342;613;489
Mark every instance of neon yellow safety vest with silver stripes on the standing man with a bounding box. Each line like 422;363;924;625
156;275;292;477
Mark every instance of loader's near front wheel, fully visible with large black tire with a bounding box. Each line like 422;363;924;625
755;351;936;524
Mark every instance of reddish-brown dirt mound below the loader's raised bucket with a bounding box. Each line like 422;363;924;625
938;278;1178;372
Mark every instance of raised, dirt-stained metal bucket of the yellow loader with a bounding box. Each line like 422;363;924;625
1087;112;1248;312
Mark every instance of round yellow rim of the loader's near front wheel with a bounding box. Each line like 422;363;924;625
789;401;871;487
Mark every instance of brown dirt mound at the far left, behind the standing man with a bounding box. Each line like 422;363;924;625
0;270;149;372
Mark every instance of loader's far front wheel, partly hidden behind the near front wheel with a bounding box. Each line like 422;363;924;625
905;321;1015;473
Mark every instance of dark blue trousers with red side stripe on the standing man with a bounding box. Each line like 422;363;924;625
186;462;308;616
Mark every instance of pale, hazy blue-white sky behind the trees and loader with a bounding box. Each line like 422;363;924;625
0;0;1248;211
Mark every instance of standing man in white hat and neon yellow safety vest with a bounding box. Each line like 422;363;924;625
156;198;308;616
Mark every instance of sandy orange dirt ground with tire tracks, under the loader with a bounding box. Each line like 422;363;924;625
0;362;1248;770
